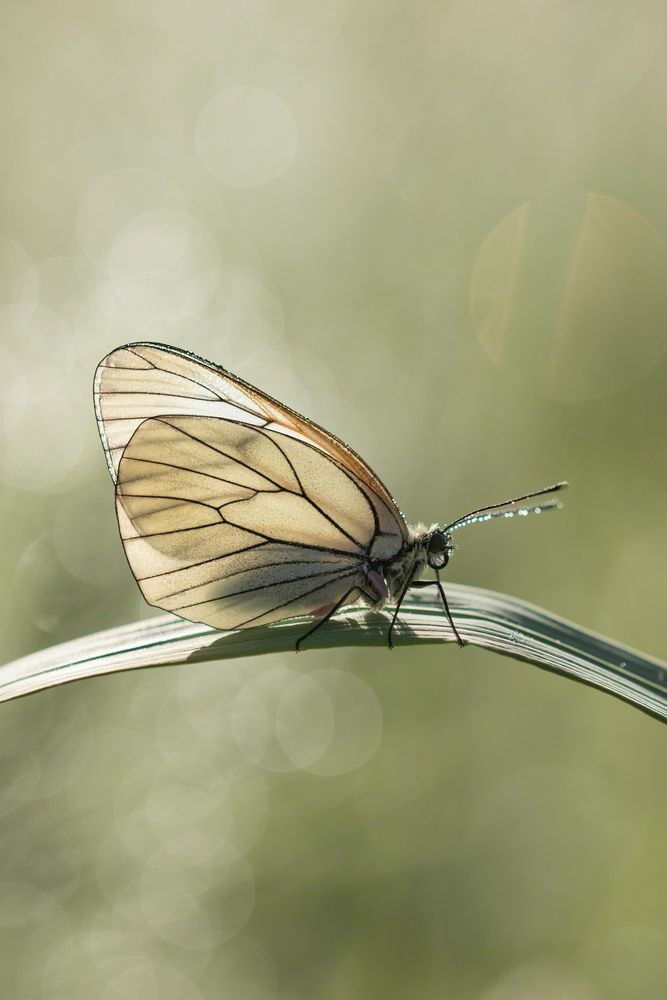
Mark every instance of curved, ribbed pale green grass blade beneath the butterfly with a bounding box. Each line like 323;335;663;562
0;583;667;720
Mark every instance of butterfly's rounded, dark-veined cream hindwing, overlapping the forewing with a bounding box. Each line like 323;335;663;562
116;416;376;628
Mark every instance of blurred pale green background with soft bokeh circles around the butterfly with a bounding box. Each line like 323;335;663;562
0;0;667;1000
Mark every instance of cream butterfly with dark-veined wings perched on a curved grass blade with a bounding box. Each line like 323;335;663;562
94;343;567;650
